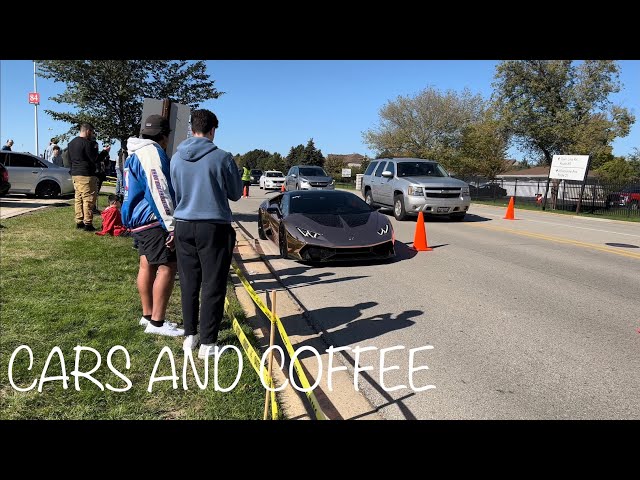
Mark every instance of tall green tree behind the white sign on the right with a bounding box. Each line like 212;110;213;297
493;60;635;167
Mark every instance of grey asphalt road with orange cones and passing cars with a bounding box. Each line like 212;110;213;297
232;187;640;419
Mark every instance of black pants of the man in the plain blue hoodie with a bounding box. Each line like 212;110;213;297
175;220;236;344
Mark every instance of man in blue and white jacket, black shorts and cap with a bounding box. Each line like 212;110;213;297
122;115;184;337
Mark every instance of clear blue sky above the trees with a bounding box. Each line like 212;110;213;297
0;60;640;159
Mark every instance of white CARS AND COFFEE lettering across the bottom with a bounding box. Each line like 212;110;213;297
7;345;436;392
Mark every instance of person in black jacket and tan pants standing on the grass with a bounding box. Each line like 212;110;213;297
68;123;98;232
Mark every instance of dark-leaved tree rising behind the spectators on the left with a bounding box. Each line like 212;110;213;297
37;60;224;146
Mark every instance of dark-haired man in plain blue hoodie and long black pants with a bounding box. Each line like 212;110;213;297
170;109;242;359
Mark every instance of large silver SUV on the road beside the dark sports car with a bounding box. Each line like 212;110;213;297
362;158;471;220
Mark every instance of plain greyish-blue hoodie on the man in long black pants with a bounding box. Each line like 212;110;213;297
171;137;242;223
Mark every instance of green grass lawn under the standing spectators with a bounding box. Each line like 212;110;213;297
0;195;272;419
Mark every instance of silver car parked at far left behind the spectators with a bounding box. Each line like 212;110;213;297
0;150;74;198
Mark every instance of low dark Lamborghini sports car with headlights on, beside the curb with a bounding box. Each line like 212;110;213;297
258;190;395;262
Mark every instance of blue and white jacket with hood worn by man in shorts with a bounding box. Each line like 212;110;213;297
122;138;175;232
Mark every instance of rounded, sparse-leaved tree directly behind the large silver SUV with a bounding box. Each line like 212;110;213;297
362;87;485;167
